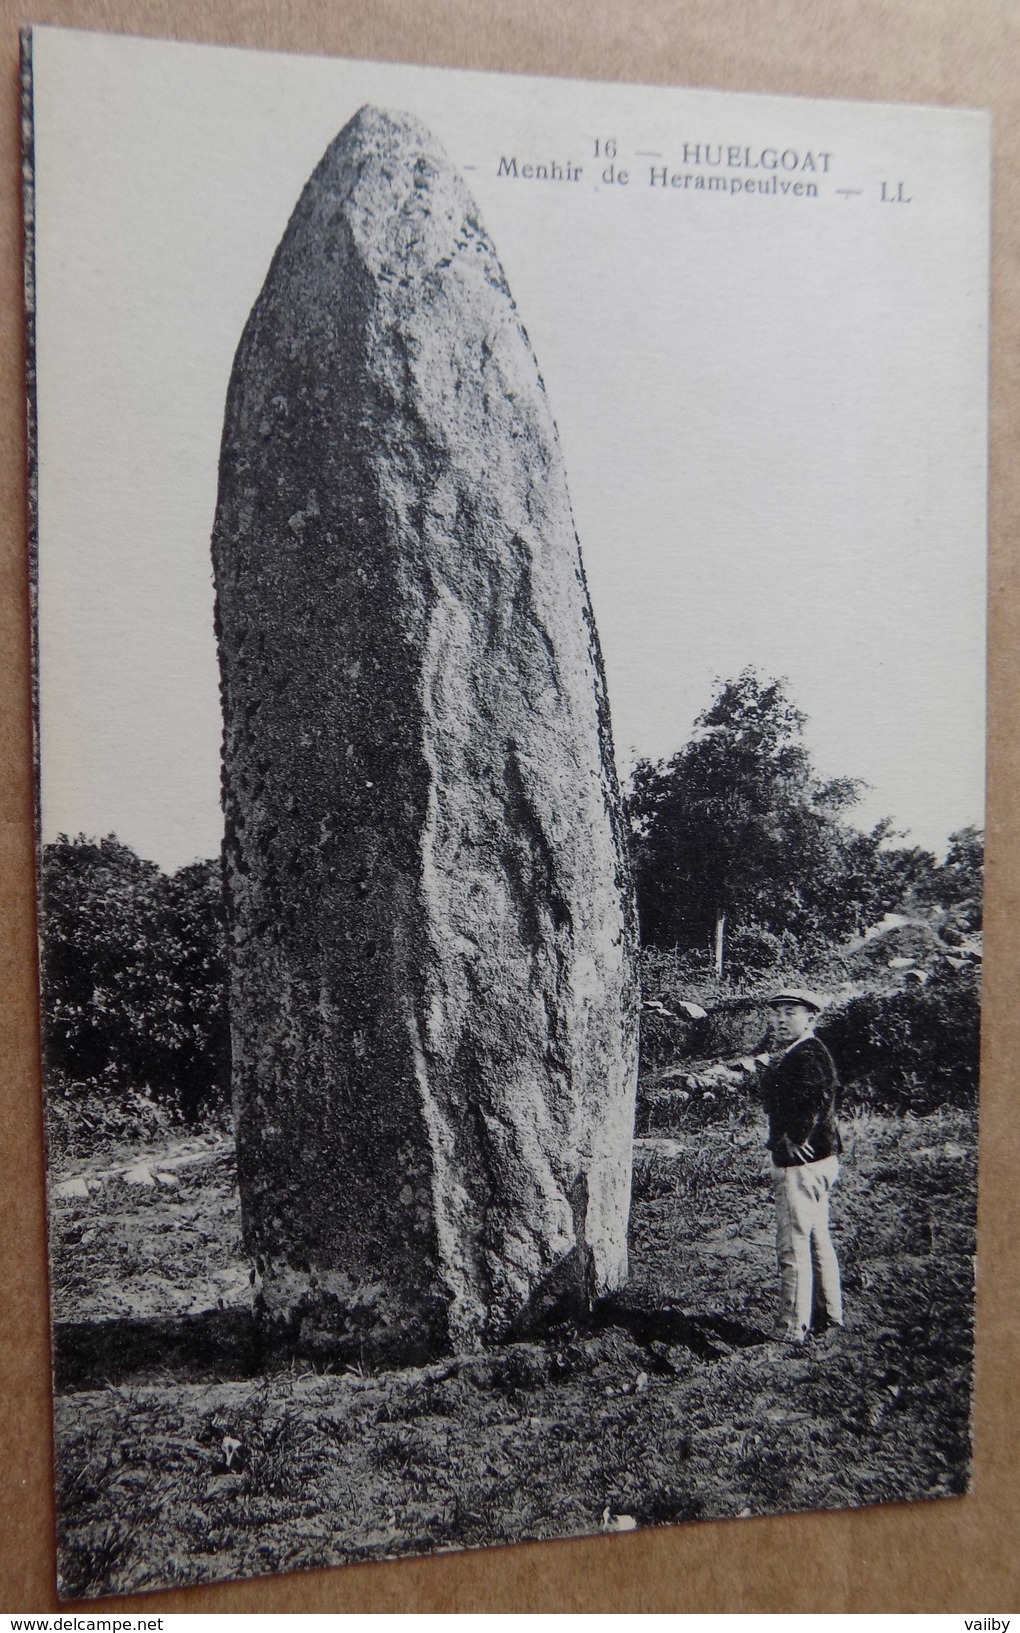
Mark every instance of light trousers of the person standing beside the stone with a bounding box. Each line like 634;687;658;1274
772;1156;842;1341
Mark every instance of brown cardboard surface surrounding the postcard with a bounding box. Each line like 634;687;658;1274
0;0;1020;1615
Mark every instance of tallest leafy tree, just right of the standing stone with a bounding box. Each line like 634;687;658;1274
628;670;909;973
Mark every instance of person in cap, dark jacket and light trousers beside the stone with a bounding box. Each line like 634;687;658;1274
761;988;844;1344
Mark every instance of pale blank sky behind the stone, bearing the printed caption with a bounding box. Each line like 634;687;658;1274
34;29;987;867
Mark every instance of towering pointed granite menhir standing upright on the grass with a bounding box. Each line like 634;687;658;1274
214;108;638;1357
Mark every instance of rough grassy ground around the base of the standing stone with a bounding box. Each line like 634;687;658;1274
52;1112;976;1597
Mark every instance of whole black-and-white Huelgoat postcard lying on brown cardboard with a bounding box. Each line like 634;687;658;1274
23;28;989;1600
